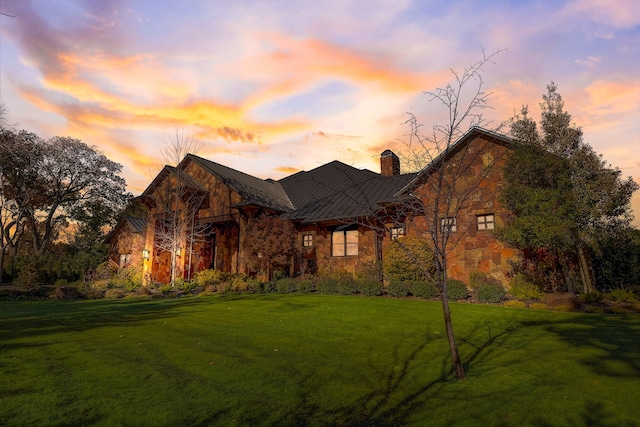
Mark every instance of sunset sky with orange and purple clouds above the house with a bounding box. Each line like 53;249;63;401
0;0;640;227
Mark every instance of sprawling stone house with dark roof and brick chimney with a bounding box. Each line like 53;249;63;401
111;128;517;288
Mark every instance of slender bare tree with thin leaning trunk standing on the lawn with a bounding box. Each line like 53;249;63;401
394;49;510;379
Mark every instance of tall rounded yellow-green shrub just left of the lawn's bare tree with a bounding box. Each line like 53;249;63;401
382;236;434;282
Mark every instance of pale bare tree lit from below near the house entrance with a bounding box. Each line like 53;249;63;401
154;130;208;286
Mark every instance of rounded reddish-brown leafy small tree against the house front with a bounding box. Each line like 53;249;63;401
246;215;298;280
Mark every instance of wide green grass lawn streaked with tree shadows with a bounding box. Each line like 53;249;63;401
0;294;640;426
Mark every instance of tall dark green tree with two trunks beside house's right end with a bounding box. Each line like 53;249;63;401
499;82;638;292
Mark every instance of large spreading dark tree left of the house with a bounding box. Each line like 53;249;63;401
0;129;130;284
